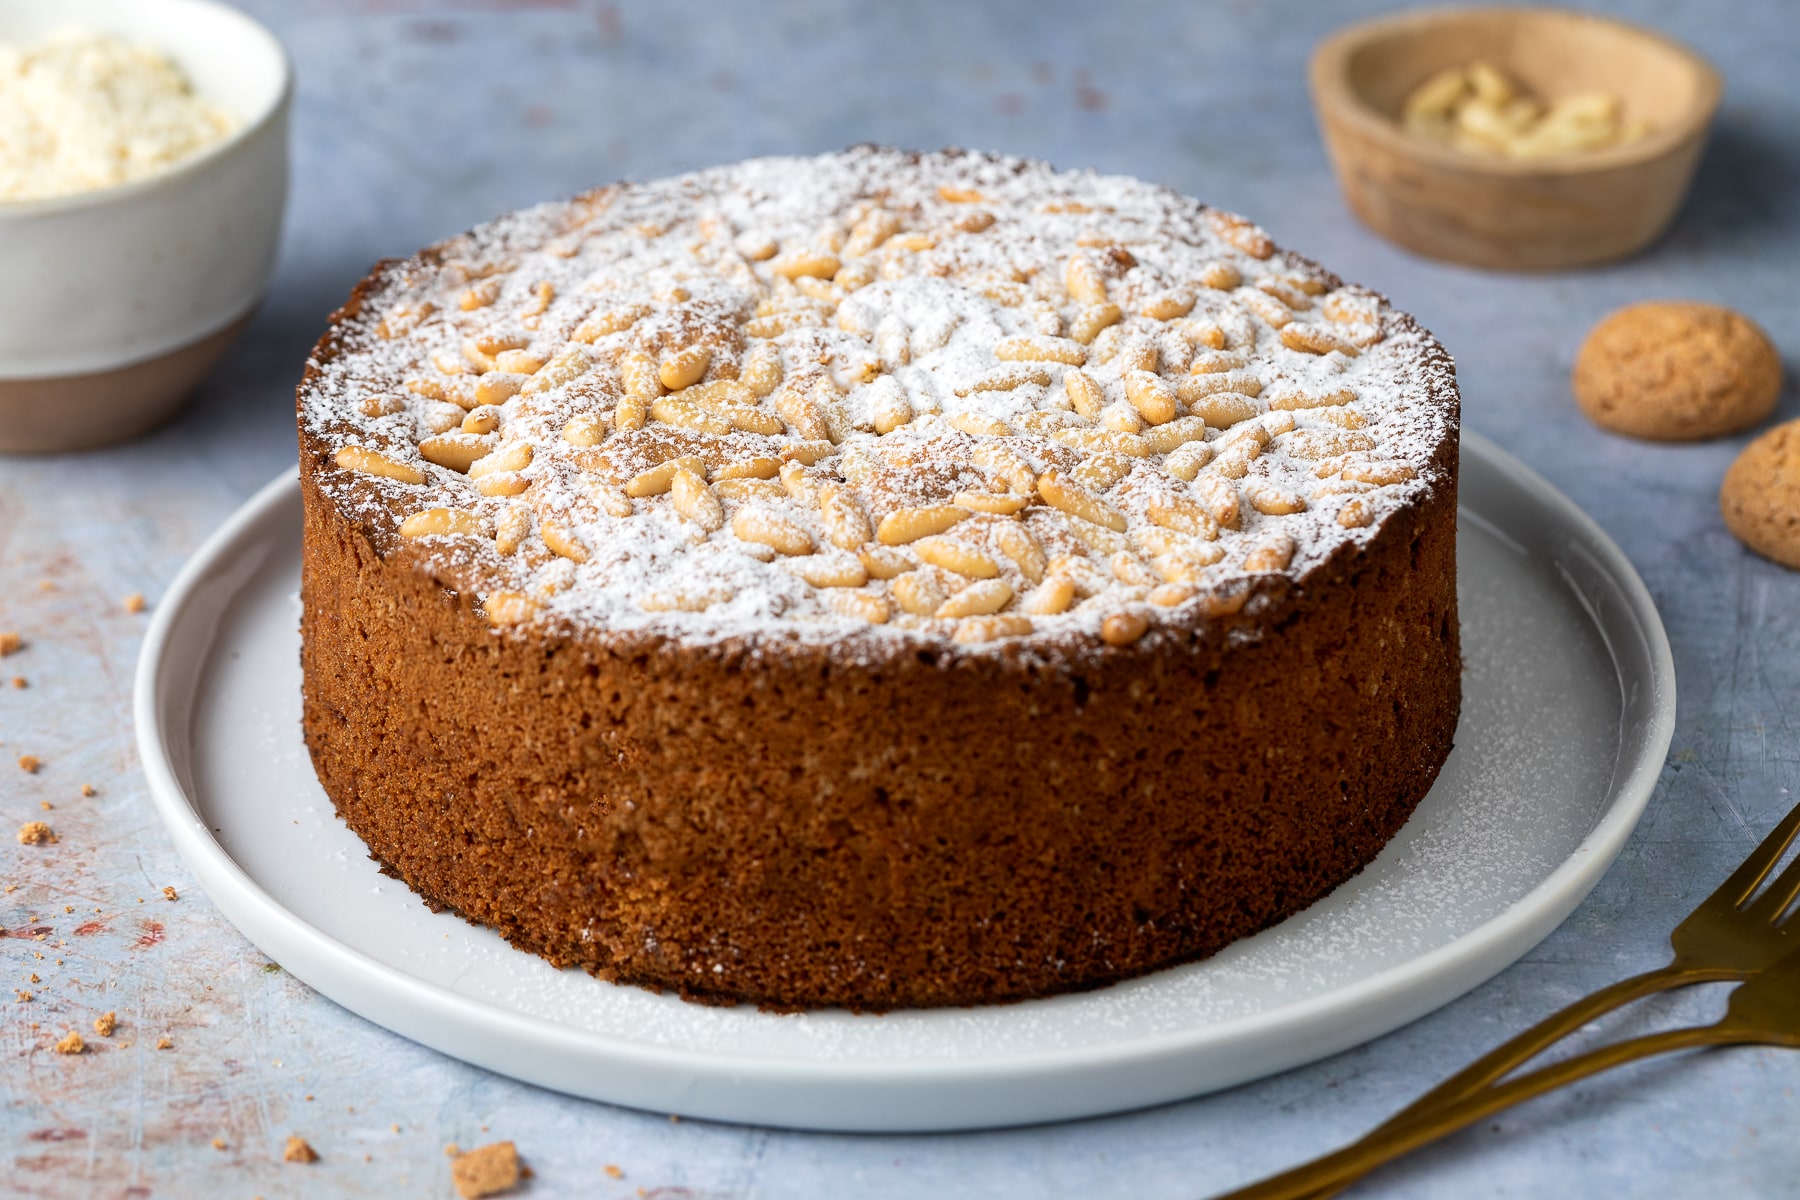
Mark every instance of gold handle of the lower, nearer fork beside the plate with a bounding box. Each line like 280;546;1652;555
1219;1018;1769;1200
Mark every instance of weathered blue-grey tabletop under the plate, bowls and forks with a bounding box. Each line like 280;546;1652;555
0;0;1800;1198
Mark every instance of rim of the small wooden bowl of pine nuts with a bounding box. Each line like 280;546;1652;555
1307;4;1724;178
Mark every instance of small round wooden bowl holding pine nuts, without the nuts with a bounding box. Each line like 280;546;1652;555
1310;7;1719;270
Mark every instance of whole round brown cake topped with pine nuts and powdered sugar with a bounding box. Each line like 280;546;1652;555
299;148;1460;1009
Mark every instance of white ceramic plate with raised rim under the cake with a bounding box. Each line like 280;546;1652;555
135;435;1676;1130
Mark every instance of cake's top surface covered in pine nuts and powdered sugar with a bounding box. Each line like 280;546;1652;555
301;148;1456;651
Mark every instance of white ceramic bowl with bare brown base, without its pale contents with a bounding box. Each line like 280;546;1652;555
0;0;293;452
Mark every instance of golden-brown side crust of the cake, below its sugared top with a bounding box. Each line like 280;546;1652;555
288;152;1460;1009
